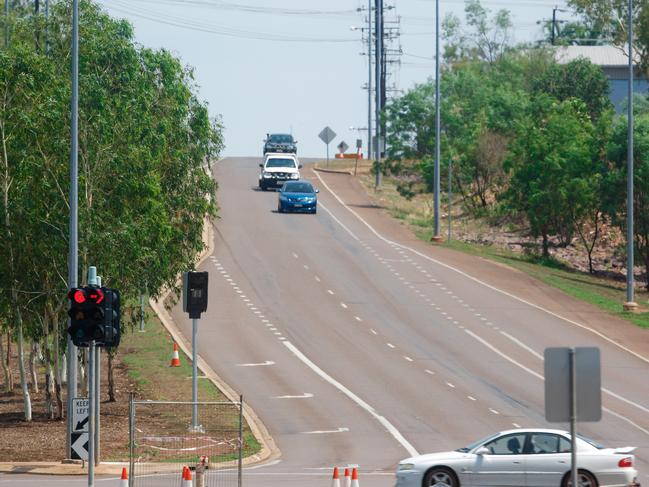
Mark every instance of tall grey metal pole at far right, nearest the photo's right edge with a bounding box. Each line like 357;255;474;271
625;0;637;309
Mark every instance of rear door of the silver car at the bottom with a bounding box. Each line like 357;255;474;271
525;432;570;487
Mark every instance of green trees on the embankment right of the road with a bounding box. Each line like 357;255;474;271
383;0;649;287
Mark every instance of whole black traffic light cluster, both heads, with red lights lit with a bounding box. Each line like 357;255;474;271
68;286;120;347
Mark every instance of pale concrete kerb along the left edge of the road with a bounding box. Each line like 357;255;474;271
149;219;281;466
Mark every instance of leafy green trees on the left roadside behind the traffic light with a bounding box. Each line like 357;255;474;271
0;0;222;421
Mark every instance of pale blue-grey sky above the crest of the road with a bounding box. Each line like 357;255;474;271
93;0;570;157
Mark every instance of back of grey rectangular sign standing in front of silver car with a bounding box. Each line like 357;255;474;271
544;347;602;423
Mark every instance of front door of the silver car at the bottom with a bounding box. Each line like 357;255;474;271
470;433;526;487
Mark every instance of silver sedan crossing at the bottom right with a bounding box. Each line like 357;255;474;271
396;429;640;487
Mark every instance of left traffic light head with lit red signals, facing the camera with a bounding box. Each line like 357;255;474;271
68;286;105;347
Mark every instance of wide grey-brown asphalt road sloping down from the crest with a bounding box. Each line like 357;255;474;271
11;158;649;487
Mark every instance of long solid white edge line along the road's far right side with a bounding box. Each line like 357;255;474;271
316;168;649;364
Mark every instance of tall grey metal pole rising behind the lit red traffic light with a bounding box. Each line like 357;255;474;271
65;0;79;462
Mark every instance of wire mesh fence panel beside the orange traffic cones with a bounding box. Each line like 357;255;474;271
129;399;246;487
